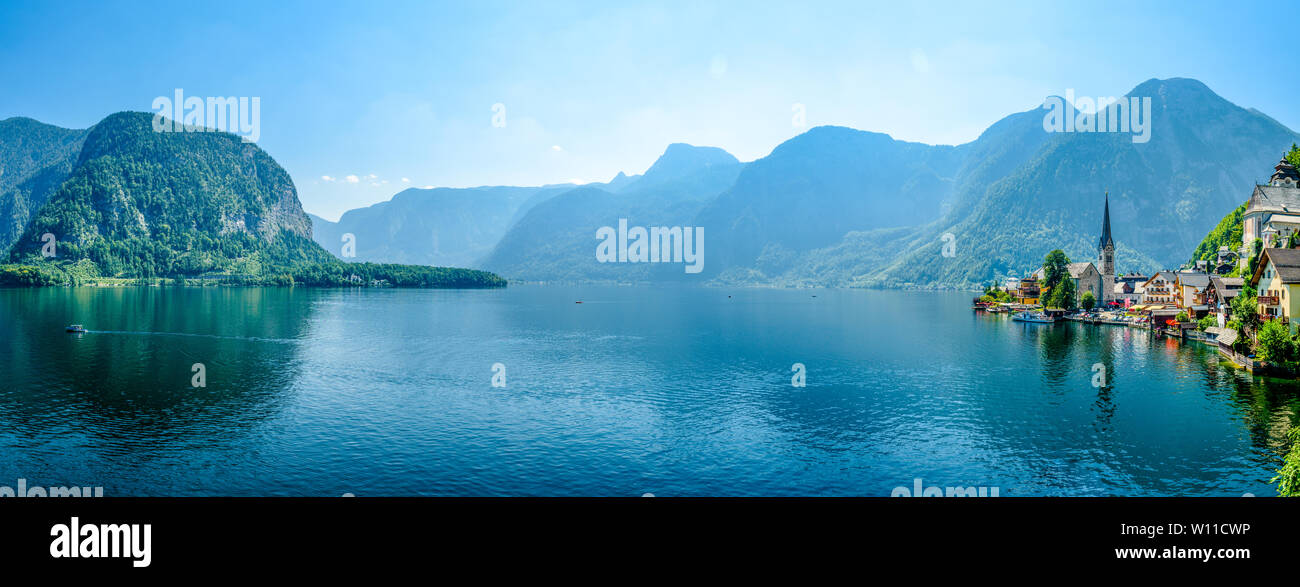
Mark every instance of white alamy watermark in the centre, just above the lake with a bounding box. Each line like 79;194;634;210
595;218;705;273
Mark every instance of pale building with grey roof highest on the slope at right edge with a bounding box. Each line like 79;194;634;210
1238;158;1300;269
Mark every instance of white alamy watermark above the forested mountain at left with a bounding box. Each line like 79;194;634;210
152;88;261;143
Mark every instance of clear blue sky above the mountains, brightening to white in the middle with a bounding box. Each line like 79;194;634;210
0;0;1300;219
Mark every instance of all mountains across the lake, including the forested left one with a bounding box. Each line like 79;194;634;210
0;78;1300;287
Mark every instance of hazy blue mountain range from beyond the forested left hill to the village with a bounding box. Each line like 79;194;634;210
306;78;1300;287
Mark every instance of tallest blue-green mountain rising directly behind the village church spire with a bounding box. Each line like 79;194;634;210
862;78;1300;286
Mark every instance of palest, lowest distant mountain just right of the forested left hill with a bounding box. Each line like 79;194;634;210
312;186;572;266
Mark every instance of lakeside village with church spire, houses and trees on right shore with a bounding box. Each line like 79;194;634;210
974;157;1300;377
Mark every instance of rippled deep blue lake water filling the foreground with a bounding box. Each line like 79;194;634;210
0;286;1300;496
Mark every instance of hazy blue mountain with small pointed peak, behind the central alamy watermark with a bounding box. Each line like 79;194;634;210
481;143;744;282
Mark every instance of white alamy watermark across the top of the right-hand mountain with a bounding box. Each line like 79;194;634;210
1043;90;1151;143
